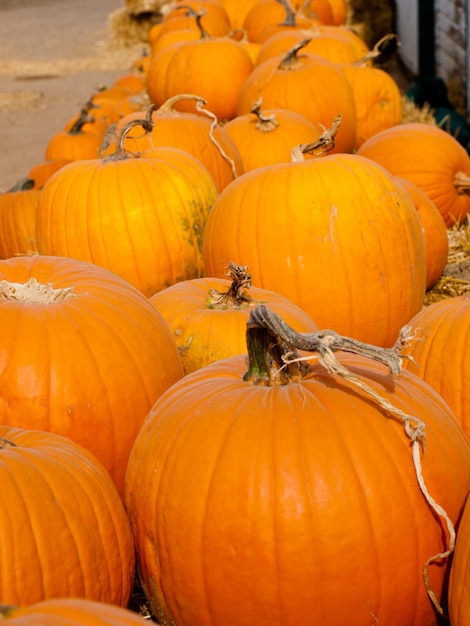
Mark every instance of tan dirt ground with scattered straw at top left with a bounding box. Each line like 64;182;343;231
0;0;149;192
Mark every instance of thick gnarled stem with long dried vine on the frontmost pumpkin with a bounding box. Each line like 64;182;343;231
243;304;456;615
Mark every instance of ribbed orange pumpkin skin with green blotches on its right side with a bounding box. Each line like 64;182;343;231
37;148;218;296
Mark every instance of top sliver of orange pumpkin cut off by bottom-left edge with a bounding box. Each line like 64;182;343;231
0;598;147;626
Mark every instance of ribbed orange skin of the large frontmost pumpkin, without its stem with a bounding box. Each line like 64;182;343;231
126;356;470;626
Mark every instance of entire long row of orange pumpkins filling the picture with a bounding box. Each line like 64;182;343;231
0;0;470;626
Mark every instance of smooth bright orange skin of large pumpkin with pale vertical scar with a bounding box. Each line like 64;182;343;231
204;154;426;346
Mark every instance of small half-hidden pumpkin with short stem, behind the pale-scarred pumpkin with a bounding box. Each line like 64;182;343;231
224;100;321;172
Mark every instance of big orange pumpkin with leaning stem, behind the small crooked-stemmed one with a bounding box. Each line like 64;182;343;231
237;39;356;152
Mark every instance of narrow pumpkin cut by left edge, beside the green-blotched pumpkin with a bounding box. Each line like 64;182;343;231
0;178;41;259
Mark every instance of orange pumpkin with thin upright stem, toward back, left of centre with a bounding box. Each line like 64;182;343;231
146;9;253;121
